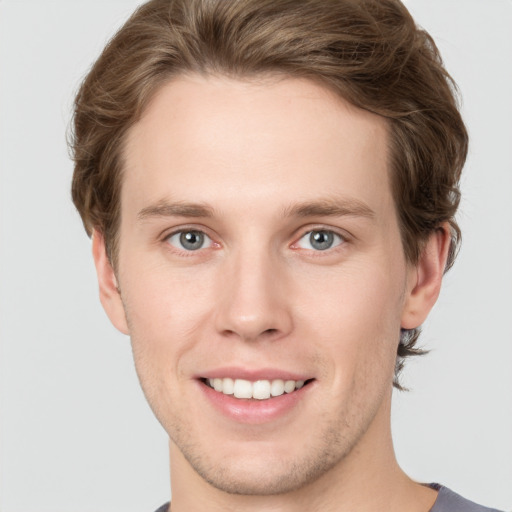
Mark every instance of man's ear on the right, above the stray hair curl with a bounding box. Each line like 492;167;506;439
401;223;451;329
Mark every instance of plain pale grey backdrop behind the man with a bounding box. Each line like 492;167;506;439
0;0;512;512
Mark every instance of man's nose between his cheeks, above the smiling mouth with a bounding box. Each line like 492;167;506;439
212;246;293;341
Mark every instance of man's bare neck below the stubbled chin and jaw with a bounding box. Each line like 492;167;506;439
170;400;437;512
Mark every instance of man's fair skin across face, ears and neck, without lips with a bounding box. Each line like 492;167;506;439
93;75;449;512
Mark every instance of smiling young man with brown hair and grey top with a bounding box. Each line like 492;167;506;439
69;0;504;512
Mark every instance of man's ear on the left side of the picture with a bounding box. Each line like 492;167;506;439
92;229;129;334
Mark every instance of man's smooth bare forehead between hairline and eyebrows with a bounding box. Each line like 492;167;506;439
122;75;390;219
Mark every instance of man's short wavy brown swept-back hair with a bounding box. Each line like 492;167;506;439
71;0;468;386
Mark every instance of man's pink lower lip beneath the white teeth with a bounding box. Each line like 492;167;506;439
198;381;313;425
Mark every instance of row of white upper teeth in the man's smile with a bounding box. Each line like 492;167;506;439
207;377;304;400
